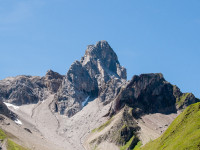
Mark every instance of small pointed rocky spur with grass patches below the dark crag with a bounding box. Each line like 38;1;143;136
88;106;140;149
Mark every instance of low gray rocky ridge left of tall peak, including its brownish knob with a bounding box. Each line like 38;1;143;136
0;70;63;105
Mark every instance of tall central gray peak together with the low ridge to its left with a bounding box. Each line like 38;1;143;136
0;41;126;116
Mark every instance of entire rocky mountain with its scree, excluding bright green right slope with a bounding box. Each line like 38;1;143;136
0;41;200;150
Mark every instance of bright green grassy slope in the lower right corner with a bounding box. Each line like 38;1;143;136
141;102;200;150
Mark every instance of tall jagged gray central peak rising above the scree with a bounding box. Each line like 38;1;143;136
54;41;126;117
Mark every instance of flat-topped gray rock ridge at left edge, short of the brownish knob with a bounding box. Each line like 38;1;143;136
0;76;44;105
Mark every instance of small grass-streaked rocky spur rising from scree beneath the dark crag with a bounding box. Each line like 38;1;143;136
90;106;141;150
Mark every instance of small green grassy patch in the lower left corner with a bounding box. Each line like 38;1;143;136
0;129;28;150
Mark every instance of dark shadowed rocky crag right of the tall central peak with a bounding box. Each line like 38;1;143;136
110;73;199;116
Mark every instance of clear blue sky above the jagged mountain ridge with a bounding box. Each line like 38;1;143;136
0;0;200;97
